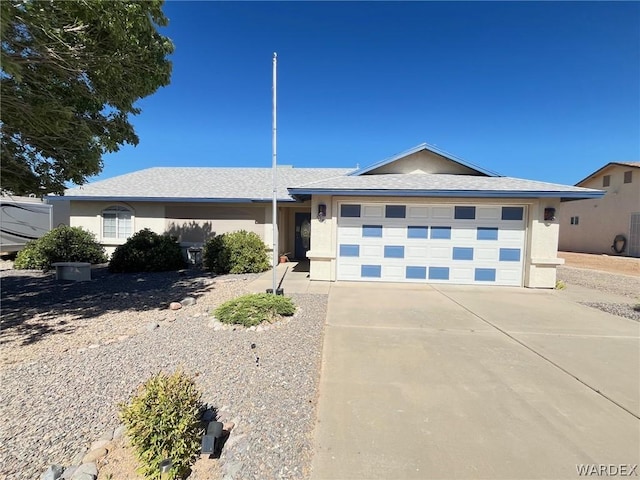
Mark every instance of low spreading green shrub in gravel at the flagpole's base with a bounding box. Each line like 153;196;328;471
214;293;296;327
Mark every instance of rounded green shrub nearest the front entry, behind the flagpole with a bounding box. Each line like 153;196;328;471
203;230;270;274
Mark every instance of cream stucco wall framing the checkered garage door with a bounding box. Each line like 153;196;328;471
307;196;563;288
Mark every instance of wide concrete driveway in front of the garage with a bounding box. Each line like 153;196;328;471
312;283;640;479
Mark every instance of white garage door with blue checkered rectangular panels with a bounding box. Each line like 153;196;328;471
337;203;526;286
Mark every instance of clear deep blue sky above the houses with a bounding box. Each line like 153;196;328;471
92;1;640;184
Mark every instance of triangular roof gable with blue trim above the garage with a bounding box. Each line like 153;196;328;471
350;143;500;177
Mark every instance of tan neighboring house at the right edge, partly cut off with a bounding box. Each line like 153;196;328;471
559;162;640;257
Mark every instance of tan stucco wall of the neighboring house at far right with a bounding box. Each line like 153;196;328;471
559;165;640;254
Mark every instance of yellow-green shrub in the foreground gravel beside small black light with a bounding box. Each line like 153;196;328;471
120;371;204;478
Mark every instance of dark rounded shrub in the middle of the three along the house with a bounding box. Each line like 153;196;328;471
109;228;185;272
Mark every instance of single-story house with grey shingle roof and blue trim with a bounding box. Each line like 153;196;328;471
49;145;603;288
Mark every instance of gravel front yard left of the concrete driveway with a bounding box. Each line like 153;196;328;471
0;269;327;480
